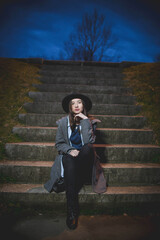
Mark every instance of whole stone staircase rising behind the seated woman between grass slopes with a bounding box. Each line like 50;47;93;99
0;61;160;214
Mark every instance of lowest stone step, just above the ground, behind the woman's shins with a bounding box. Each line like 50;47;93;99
0;183;160;215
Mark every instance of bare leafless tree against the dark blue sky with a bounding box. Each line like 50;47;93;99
64;10;116;61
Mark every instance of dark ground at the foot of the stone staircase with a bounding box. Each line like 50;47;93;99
0;205;160;240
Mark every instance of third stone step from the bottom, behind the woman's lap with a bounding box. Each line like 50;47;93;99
5;142;160;163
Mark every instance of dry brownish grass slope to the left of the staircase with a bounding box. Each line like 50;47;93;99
0;58;40;160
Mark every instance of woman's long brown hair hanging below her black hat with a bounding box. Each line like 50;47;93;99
69;100;88;131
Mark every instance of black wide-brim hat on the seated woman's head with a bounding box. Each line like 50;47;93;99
62;93;92;113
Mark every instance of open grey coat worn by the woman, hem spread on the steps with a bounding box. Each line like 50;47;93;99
44;116;106;193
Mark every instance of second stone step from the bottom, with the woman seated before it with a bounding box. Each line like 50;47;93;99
0;161;160;186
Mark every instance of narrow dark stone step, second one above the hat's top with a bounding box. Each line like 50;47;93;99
38;75;125;86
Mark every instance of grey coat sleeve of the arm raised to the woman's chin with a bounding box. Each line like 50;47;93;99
80;119;96;144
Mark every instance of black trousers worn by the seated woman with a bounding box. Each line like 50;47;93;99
62;144;94;212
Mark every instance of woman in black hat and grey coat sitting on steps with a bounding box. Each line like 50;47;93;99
44;93;106;229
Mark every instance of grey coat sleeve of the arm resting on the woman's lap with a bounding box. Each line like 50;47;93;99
55;118;75;154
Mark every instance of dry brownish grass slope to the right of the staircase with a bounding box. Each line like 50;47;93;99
124;63;160;145
